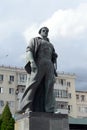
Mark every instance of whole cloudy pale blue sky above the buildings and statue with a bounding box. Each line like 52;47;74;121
0;0;87;90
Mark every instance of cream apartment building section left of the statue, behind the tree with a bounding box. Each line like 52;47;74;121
0;66;26;114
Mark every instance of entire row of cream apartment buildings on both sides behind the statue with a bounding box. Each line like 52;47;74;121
0;66;87;118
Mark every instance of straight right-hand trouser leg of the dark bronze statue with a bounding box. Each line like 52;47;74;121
45;65;55;112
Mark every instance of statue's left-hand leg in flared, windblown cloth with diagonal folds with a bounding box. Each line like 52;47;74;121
21;65;44;111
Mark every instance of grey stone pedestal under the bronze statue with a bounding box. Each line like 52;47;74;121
15;112;69;130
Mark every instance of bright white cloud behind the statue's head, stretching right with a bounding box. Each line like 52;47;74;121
25;3;87;39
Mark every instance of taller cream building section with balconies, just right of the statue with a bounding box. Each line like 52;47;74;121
54;72;77;117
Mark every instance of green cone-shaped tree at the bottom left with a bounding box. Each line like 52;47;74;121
0;103;15;130
